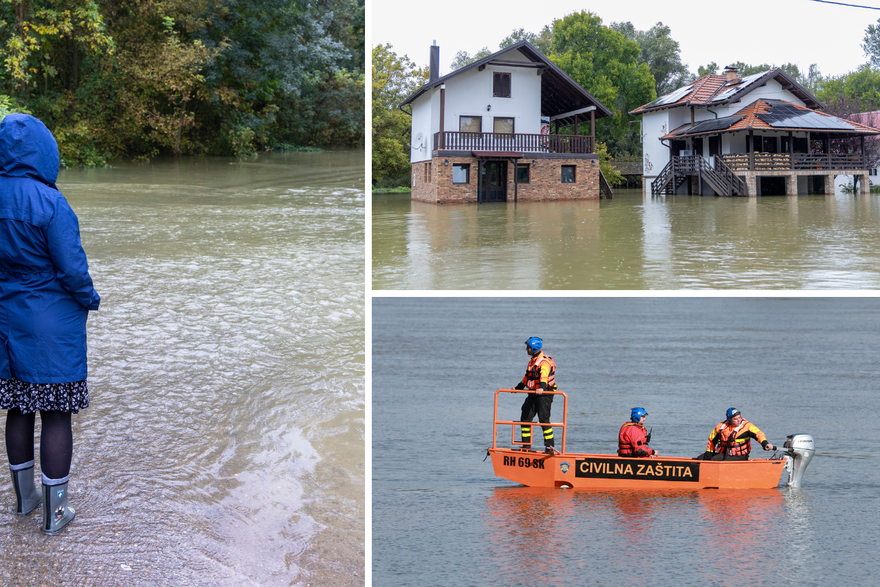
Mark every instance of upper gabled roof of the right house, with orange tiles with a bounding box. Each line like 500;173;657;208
630;68;824;114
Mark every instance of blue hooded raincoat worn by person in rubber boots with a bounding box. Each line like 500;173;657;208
0;114;101;383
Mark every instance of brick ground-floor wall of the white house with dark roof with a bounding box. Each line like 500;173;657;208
412;156;599;204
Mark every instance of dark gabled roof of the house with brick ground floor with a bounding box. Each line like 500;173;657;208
400;41;613;118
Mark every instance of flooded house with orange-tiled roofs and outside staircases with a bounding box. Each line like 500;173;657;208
630;67;880;196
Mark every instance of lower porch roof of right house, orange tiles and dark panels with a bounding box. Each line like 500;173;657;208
660;98;880;140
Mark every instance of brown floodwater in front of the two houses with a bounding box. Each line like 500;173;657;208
372;190;880;290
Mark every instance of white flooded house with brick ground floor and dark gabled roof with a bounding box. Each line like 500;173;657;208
400;41;612;204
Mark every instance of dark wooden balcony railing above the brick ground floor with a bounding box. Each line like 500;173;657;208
434;131;593;154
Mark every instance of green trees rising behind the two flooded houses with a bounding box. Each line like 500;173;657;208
373;12;880;183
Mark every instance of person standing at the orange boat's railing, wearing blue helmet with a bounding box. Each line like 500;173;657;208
515;336;556;454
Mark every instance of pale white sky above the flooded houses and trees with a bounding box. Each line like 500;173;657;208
368;0;880;84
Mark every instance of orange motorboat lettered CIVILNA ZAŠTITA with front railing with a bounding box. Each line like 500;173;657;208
488;389;814;489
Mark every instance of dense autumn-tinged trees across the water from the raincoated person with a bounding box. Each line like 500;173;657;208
0;0;365;165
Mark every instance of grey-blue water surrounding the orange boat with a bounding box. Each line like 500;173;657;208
372;297;880;586
